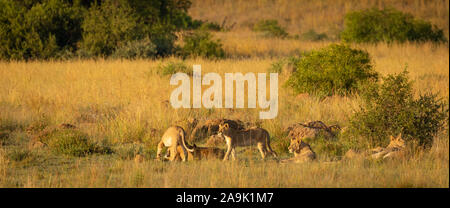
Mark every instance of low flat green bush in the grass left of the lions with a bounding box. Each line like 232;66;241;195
42;129;110;157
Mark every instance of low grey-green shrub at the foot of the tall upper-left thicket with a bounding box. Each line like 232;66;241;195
112;39;157;59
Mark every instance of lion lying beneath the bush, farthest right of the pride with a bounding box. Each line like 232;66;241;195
371;134;406;159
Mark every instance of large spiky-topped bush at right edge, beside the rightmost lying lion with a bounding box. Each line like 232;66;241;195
350;71;448;147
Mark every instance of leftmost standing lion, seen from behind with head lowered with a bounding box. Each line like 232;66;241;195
156;126;194;162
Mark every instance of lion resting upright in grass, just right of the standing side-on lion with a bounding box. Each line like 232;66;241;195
281;138;316;163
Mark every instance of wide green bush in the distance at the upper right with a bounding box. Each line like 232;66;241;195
341;9;447;43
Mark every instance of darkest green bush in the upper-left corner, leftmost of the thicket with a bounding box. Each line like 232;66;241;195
0;0;83;60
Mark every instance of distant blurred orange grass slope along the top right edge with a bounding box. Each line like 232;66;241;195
189;0;449;37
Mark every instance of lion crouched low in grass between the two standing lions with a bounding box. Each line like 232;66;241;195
170;144;225;161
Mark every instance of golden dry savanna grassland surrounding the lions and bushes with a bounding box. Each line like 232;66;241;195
0;1;449;188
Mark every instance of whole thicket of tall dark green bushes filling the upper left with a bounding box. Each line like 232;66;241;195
0;0;197;60
